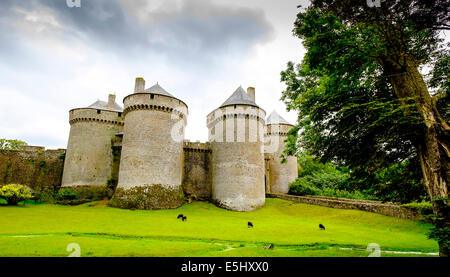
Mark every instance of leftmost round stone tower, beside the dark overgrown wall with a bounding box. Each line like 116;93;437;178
62;94;123;187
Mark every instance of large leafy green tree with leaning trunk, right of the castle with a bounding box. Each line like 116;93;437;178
281;0;450;256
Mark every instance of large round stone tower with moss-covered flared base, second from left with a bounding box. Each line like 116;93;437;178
111;78;188;209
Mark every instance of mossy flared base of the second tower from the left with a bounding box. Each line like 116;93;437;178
109;184;185;210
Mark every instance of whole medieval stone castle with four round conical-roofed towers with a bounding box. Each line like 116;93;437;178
62;78;297;211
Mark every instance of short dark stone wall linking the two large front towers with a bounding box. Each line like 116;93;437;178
183;142;212;200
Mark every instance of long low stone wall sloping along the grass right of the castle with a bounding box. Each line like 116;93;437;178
266;193;422;221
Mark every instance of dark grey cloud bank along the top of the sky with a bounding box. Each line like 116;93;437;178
0;0;273;62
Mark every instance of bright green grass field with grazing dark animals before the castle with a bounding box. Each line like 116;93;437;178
0;199;438;257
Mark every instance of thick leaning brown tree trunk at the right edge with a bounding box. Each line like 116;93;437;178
382;56;450;257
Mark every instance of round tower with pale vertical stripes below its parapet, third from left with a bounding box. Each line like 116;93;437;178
207;87;265;211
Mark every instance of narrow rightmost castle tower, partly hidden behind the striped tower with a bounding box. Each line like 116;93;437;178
264;111;298;193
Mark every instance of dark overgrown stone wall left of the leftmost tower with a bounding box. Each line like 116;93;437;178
0;147;66;190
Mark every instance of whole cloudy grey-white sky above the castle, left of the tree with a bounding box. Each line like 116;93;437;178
0;0;307;148
